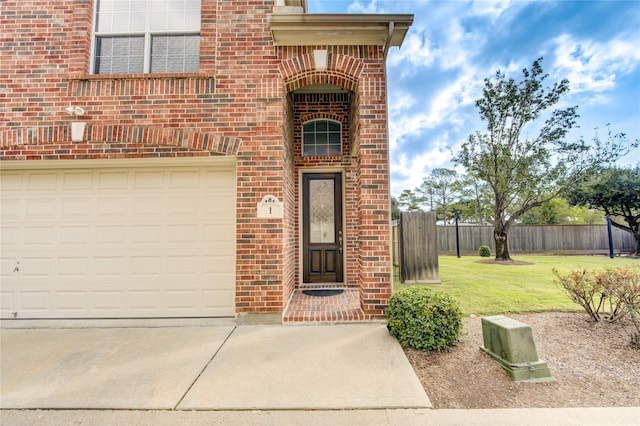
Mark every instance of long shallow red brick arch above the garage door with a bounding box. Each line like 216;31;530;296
0;124;241;159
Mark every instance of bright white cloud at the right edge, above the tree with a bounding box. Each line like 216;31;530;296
552;34;640;93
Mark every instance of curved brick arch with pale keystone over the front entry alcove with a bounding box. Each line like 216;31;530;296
279;52;364;92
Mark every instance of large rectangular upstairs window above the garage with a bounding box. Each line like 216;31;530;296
93;0;200;74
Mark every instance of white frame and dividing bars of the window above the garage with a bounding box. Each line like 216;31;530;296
89;0;202;75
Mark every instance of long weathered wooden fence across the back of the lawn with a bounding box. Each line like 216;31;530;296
437;225;635;254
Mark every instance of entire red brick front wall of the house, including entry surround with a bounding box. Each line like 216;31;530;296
0;0;391;317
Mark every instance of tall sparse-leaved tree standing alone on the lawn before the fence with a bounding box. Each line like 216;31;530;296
453;58;638;260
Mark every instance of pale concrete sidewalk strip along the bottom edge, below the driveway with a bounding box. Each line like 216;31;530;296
0;407;640;426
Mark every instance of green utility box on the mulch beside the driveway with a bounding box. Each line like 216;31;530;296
480;315;555;382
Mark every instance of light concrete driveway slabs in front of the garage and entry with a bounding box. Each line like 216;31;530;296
0;321;431;410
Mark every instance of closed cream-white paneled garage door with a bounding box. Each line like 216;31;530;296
0;159;235;318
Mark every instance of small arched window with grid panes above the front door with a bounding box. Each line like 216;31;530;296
302;120;342;157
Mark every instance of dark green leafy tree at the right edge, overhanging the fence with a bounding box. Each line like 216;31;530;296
567;164;640;256
